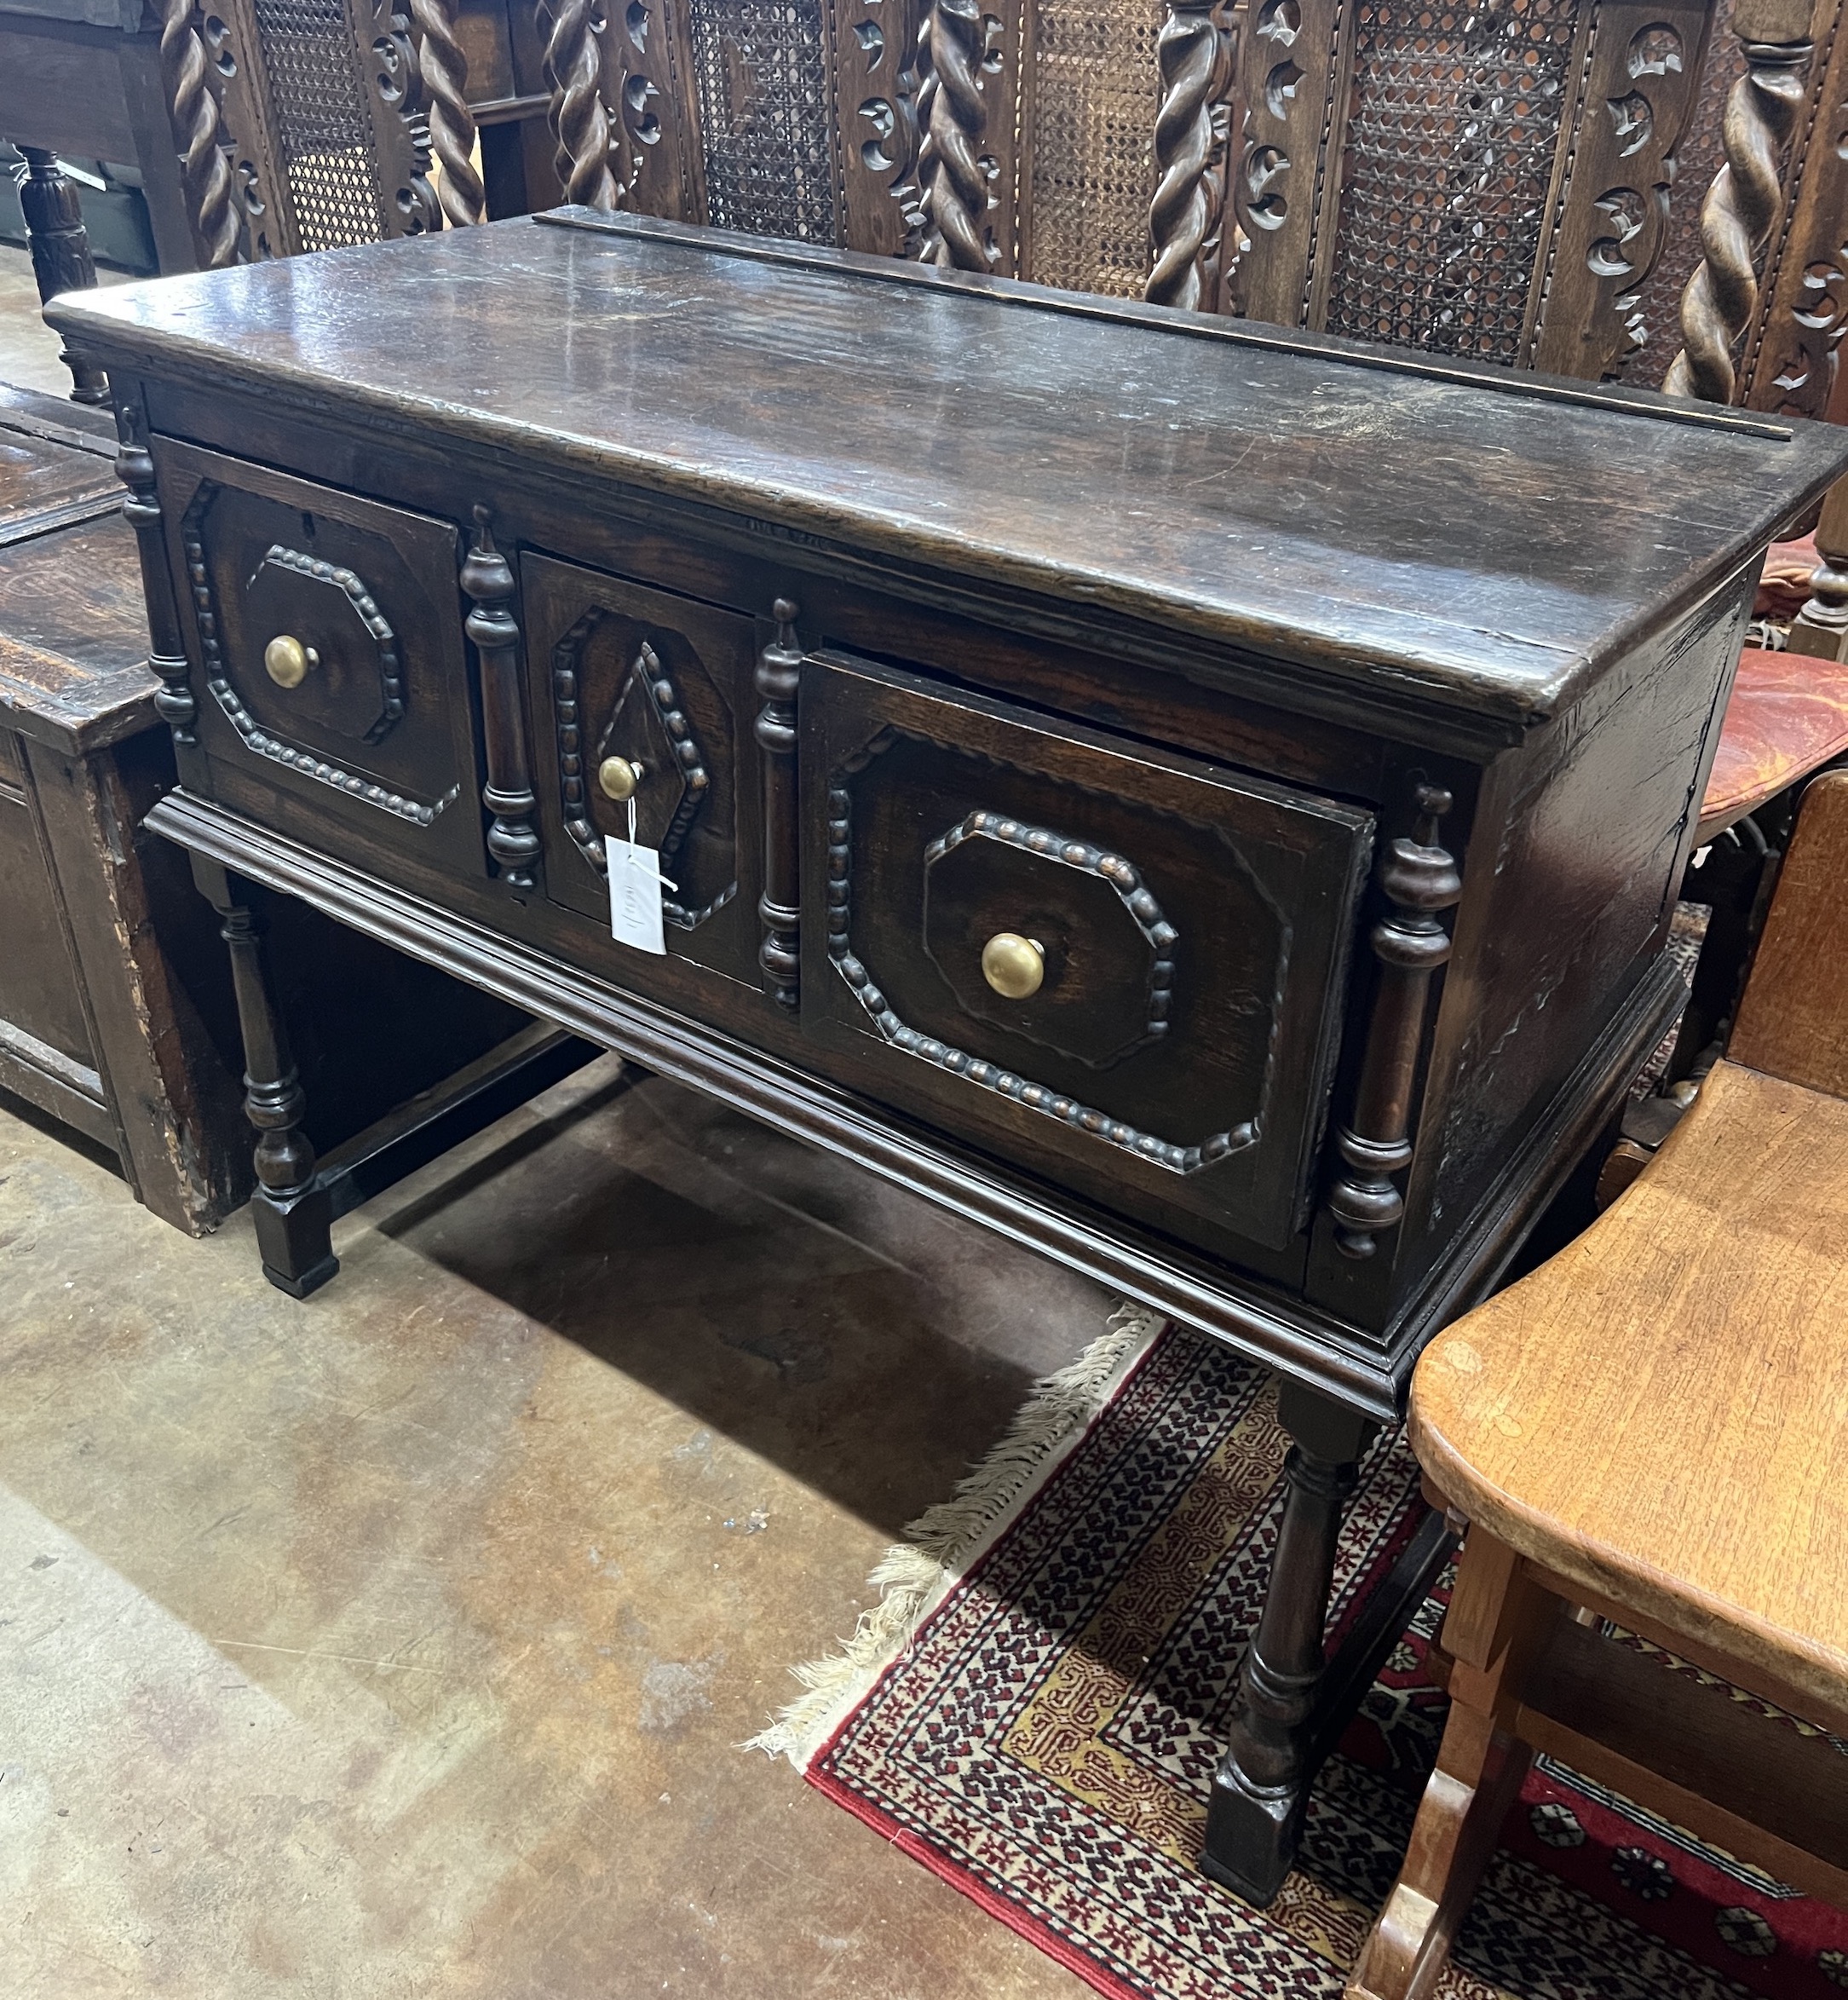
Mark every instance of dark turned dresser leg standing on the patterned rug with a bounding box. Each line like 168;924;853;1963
1200;1380;1378;1908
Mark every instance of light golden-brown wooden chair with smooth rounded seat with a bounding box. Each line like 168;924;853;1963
1348;772;1848;2000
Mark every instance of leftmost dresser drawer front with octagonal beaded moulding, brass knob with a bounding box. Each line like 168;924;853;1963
154;438;488;876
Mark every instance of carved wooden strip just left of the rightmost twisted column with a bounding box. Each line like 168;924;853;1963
1532;0;1708;382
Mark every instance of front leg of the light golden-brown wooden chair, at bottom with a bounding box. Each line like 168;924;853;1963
1346;1528;1560;2000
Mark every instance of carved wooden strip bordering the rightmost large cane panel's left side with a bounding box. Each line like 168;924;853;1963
1222;0;1352;326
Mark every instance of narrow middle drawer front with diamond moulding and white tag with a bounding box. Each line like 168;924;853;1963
520;550;762;984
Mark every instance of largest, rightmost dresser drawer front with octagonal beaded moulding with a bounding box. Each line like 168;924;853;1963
800;654;1372;1248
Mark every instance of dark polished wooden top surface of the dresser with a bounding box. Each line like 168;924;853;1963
48;210;1848;724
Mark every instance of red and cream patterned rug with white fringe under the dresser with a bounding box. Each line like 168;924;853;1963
760;1314;1848;2000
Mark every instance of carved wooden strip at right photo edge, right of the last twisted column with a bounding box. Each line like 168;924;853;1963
1738;3;1848;418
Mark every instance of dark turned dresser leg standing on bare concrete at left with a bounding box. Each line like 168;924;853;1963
192;856;340;1298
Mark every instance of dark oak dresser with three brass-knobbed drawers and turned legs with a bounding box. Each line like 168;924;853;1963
50;210;1848;1900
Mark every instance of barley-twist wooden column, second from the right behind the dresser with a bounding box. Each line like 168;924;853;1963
1144;0;1232;310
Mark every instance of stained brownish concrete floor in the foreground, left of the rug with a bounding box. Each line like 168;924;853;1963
0;1058;1108;2000
